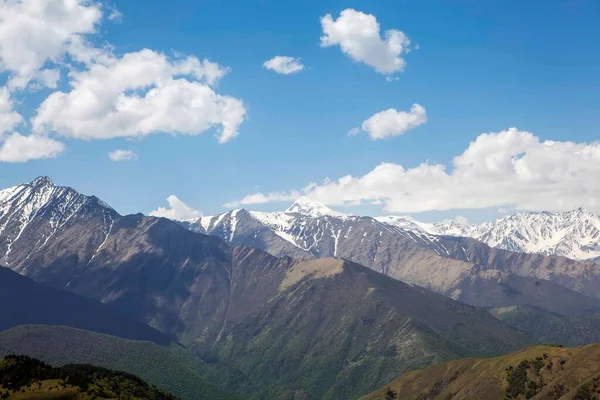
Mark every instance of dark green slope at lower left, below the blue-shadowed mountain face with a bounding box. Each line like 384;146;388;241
0;325;241;400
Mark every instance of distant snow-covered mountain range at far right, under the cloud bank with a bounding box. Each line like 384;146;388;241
377;208;600;260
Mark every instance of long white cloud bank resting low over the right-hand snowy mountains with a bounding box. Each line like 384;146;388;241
225;128;600;213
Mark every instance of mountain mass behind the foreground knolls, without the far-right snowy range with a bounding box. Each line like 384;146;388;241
5;177;600;399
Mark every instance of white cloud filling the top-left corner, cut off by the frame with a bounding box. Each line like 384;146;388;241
0;0;102;89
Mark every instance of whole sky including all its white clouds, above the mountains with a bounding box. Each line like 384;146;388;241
0;0;600;222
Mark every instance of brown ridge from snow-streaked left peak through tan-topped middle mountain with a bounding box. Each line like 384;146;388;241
0;179;525;398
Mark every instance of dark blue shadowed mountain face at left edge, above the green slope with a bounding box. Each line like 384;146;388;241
0;267;171;344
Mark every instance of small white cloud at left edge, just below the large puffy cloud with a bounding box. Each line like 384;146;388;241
0;133;65;163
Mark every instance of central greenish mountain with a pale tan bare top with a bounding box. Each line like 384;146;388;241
211;259;524;399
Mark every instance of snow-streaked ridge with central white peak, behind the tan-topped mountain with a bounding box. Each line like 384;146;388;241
181;199;600;305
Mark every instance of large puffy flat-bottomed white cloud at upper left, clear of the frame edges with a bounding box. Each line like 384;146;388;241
33;49;246;143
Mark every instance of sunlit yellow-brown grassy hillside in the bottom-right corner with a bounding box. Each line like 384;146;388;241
364;344;600;400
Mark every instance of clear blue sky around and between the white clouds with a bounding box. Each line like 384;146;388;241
0;0;600;221
